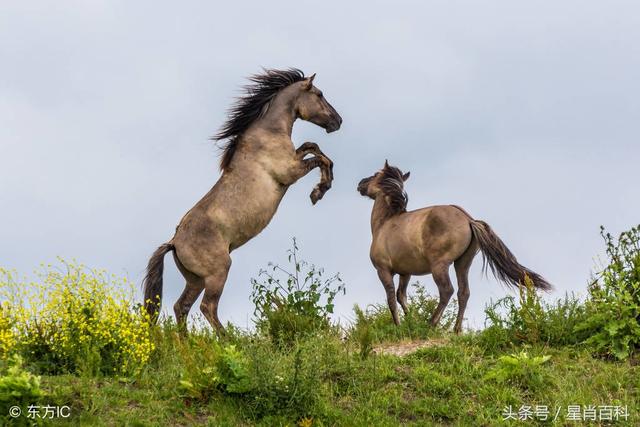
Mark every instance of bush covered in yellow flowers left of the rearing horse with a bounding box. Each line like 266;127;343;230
0;261;153;375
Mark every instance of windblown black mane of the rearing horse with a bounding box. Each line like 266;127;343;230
211;68;305;170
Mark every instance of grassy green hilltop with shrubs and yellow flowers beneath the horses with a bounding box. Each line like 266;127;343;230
0;227;640;426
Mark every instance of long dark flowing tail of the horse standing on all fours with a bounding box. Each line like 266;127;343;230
471;220;553;291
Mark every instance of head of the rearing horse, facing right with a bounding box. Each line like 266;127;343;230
296;74;342;133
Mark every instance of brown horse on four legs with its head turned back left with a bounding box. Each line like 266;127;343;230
358;162;551;333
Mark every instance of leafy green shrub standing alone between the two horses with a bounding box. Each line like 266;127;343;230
251;239;345;344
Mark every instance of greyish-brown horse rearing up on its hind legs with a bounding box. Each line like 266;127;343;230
143;69;342;331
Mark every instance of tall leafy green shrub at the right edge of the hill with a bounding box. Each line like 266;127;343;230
577;226;640;359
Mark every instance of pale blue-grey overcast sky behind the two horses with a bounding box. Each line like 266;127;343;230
0;1;640;327
